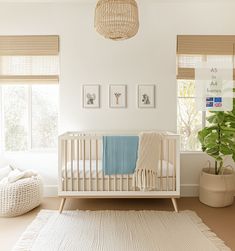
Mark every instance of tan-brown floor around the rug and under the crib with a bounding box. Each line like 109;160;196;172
0;198;235;251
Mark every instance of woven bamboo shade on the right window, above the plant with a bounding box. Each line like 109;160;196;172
177;35;235;80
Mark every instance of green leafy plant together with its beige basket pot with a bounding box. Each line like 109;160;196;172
198;95;235;207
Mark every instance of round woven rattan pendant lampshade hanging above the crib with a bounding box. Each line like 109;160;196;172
95;0;139;40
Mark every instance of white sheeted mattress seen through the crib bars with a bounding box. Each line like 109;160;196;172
62;160;175;179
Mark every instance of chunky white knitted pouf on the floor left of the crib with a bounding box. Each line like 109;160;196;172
0;176;42;217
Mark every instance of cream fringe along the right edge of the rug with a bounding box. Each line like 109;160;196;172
185;210;232;251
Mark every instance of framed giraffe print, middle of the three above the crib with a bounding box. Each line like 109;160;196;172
109;85;127;108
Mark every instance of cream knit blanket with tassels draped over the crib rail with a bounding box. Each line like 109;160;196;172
134;132;163;191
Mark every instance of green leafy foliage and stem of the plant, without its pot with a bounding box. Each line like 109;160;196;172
198;92;235;175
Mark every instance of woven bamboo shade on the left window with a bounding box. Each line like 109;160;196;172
0;35;59;84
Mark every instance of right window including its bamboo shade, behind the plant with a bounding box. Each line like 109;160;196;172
177;35;235;151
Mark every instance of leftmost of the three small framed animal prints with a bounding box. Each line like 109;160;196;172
82;85;100;108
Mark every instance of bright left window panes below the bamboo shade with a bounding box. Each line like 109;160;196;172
0;84;58;151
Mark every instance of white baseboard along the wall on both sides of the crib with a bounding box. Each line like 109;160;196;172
43;184;199;197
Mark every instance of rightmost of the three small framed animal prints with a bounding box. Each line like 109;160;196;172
137;84;156;108
